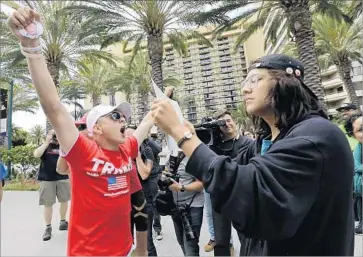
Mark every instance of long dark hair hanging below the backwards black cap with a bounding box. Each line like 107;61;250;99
252;69;328;136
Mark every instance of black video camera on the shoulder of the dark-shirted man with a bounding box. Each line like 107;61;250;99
194;117;226;146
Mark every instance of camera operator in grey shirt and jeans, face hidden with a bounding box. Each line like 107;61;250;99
169;155;204;256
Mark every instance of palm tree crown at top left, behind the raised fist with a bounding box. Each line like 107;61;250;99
4;0;113;87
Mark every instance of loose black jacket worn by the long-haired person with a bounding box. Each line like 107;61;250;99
187;116;354;256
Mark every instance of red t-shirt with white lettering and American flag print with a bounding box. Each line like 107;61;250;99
64;135;138;256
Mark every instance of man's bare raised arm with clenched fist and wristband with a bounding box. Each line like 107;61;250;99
8;7;78;152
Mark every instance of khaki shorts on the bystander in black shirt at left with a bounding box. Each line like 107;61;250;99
39;179;71;206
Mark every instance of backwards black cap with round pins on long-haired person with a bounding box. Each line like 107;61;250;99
251;54;318;100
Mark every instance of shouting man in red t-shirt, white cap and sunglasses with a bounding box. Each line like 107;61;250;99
8;7;154;256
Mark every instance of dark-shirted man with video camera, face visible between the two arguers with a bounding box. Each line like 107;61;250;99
205;110;253;256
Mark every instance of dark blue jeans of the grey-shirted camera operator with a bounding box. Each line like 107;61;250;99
172;207;203;256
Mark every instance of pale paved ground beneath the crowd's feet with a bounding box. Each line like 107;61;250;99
1;191;363;256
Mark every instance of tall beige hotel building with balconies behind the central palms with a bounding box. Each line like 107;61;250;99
85;27;264;124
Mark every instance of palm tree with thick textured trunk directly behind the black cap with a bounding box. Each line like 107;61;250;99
195;0;358;102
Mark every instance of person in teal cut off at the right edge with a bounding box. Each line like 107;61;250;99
345;113;363;234
